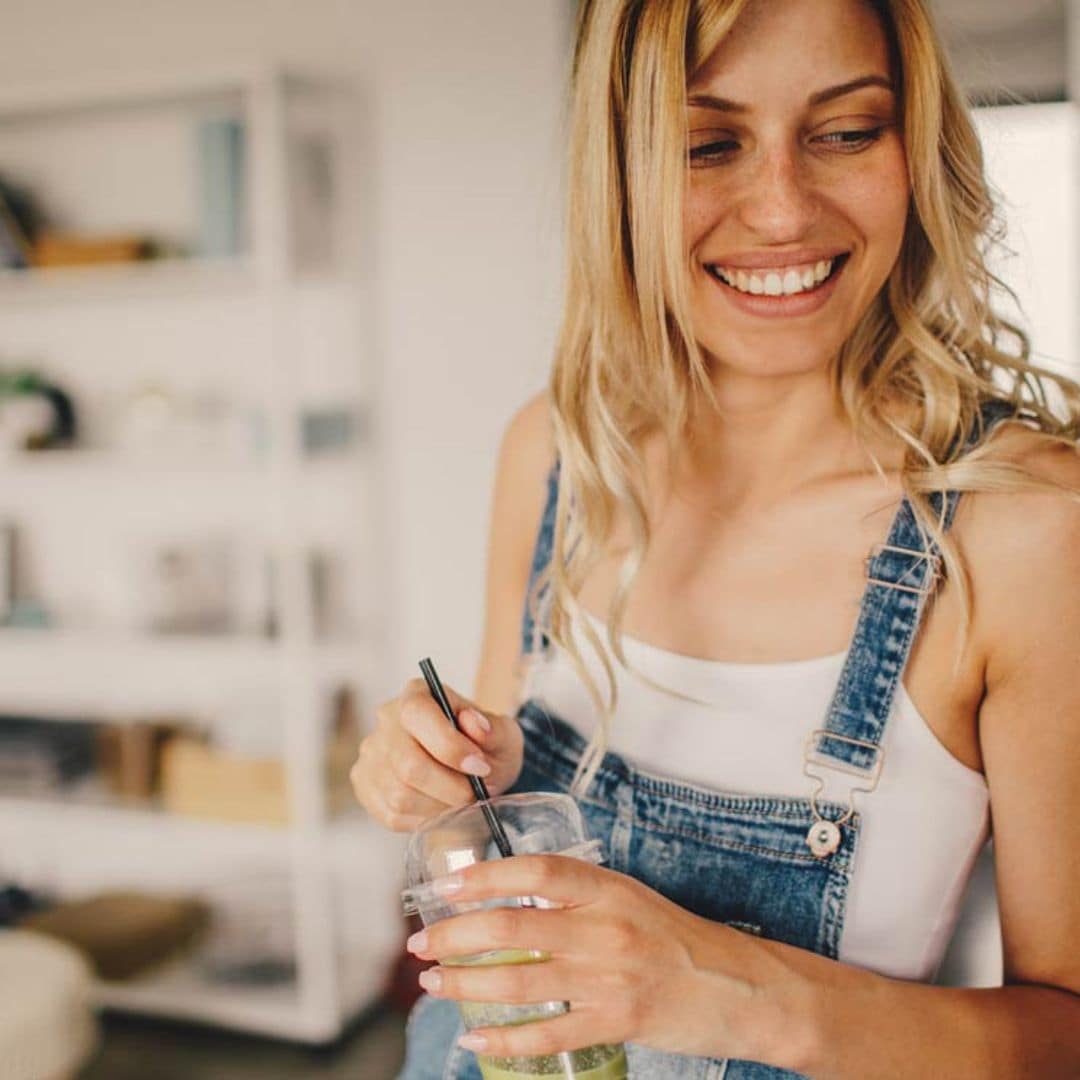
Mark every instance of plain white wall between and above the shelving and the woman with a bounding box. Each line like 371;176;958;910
0;0;569;697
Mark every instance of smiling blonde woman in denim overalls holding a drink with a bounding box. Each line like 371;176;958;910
354;0;1080;1080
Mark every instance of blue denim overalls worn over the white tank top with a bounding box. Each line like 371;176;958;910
399;403;1013;1080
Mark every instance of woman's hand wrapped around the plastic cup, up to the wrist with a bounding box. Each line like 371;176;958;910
408;855;761;1057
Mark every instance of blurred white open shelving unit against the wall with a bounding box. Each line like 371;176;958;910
0;67;401;1041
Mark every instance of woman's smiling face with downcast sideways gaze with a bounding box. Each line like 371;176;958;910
685;0;909;384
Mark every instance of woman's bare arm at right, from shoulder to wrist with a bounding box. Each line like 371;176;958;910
738;442;1080;1080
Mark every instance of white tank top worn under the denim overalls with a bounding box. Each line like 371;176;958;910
525;615;989;981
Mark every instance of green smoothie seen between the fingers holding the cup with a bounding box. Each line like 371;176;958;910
443;949;627;1080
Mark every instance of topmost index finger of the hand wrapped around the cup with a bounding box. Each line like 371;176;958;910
442;855;622;907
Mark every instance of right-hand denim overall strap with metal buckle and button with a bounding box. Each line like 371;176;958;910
805;401;1015;854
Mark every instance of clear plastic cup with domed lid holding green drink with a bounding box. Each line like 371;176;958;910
402;794;626;1080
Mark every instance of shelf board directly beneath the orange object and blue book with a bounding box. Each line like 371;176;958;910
0;257;255;303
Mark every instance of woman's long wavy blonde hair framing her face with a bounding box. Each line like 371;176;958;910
528;0;1080;792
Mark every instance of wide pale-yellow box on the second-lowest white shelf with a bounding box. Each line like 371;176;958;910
161;735;289;825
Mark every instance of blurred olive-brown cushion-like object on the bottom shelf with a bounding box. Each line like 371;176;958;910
23;892;210;980
